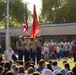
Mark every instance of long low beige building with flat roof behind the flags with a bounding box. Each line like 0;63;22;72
0;23;76;50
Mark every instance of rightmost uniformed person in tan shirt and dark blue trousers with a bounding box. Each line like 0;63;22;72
35;36;42;64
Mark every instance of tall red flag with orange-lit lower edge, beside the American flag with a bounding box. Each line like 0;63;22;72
31;5;40;38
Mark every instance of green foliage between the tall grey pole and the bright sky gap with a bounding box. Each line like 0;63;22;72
10;0;24;24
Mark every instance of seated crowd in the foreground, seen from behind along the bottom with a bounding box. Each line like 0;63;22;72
0;56;76;75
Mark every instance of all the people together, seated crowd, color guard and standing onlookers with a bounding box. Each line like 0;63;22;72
0;36;76;75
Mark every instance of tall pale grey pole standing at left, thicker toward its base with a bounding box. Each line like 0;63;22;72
6;0;10;49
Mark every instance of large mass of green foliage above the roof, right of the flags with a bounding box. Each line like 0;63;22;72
40;0;76;24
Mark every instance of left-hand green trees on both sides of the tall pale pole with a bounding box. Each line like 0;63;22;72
0;0;31;28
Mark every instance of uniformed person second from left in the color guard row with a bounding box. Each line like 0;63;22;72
24;37;30;62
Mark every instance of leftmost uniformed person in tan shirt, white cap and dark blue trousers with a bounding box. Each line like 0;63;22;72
16;36;23;60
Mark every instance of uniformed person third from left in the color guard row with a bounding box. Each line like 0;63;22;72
30;38;36;63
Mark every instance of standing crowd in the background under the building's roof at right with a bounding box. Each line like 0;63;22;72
41;42;76;61
